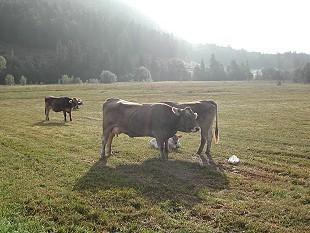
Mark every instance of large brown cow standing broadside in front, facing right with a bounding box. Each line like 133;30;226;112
101;99;199;160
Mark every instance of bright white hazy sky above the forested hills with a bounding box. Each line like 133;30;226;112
124;0;310;54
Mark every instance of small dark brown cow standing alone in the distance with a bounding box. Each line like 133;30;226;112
45;96;77;121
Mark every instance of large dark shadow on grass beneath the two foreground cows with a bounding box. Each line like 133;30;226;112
74;158;229;203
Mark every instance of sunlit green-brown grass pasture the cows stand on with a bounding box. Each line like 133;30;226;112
0;82;310;233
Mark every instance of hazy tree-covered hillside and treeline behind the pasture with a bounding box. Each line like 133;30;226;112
0;0;310;84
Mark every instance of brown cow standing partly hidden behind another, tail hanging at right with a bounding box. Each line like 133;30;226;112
163;100;219;155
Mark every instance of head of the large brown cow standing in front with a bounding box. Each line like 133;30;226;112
172;107;200;132
